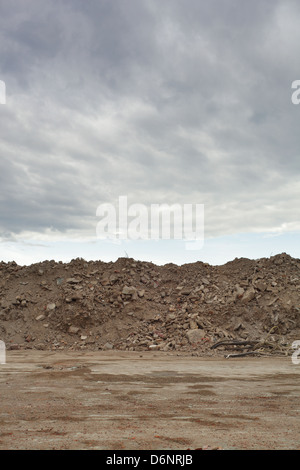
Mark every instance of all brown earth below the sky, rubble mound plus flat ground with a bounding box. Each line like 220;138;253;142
0;253;300;450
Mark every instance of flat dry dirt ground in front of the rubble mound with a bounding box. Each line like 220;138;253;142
0;350;300;450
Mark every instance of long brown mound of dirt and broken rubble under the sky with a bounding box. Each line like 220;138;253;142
0;253;300;355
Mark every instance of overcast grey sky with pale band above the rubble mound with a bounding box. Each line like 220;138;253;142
0;0;300;264
